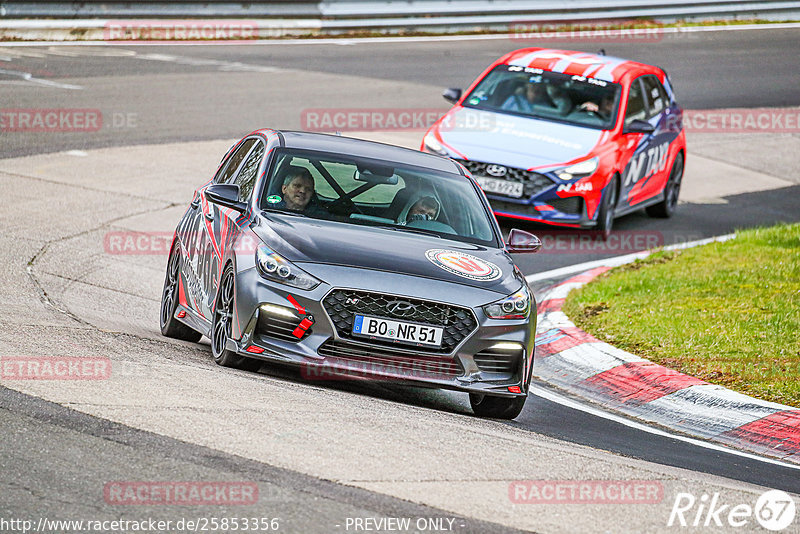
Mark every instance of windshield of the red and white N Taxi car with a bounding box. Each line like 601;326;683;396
464;65;620;130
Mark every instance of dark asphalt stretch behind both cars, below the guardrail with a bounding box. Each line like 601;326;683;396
0;29;800;157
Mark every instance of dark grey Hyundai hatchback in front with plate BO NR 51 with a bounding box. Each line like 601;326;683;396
160;129;541;419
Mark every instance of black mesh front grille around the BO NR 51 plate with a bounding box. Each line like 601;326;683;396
322;289;478;353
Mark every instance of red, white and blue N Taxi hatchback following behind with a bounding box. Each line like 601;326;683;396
421;48;686;236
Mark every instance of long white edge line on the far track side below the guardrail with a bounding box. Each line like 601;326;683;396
0;21;800;48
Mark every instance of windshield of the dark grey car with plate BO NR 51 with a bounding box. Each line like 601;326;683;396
260;149;499;247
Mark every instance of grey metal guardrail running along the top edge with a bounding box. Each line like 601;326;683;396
0;0;800;40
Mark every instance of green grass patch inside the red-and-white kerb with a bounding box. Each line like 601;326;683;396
564;224;800;407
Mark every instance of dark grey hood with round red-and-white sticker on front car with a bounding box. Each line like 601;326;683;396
253;213;522;295
